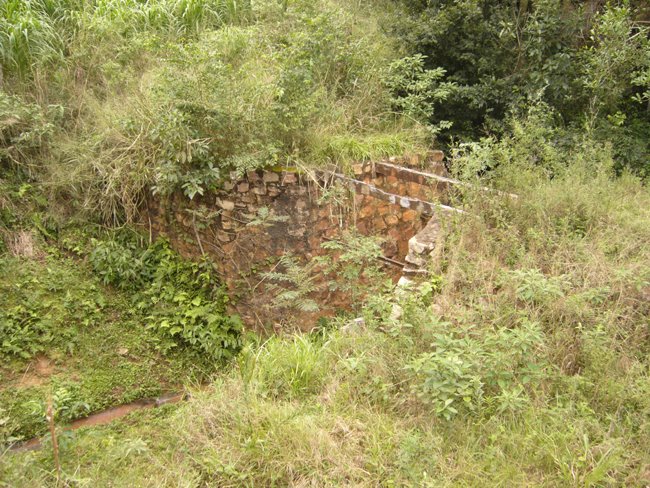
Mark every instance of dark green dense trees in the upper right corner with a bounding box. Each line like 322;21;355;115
395;0;650;174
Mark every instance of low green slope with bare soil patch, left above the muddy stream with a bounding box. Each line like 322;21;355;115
0;249;205;438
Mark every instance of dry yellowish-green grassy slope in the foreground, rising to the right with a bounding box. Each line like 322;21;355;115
2;140;650;486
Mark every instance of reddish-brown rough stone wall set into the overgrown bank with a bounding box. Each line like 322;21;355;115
144;154;450;328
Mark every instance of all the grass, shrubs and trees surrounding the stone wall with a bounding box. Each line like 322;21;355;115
0;0;650;487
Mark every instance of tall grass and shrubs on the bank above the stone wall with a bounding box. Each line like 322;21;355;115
0;0;427;224
